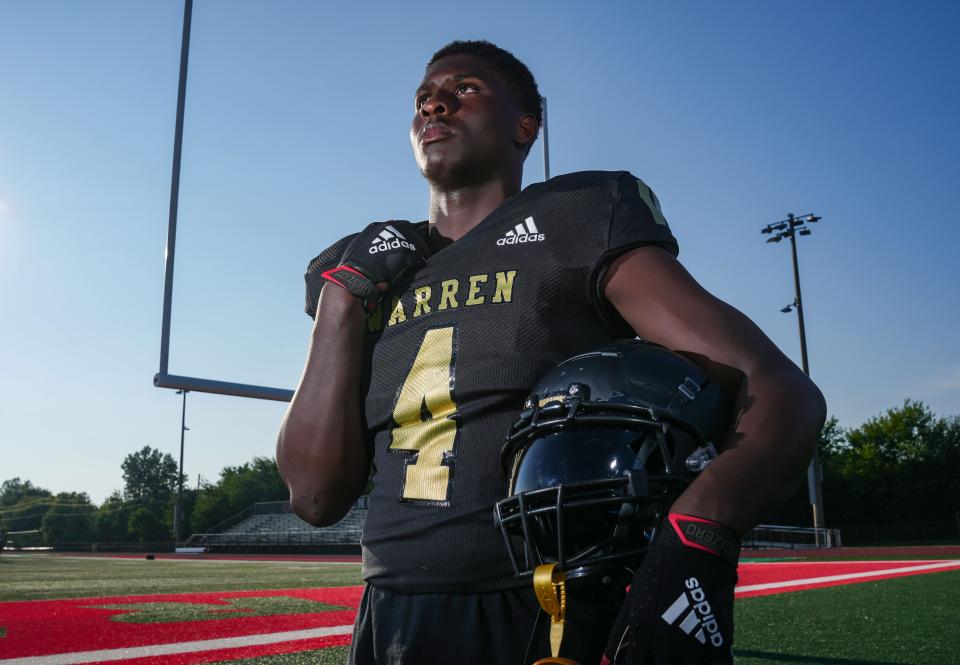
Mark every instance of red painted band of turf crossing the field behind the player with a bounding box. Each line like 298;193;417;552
0;553;960;665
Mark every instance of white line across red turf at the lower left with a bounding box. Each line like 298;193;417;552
0;625;353;665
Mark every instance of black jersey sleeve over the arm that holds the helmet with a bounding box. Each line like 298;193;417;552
591;172;680;336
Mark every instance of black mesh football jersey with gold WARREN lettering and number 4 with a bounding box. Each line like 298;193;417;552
307;171;677;593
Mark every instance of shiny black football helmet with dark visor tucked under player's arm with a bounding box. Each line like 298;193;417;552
495;340;732;582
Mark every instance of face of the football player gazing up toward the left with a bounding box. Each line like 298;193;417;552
410;55;520;189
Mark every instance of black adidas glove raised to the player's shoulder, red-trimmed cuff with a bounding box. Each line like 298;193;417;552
321;220;430;313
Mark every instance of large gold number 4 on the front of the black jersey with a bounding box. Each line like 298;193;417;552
390;327;457;504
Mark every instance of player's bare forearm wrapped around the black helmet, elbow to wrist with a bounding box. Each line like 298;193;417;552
672;366;826;534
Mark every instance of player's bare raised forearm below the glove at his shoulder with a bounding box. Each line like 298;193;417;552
277;286;369;526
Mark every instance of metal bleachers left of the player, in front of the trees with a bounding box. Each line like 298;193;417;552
184;497;367;554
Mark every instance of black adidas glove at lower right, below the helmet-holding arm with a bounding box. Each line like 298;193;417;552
603;513;740;665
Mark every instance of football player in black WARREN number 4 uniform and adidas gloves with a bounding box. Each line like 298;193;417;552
277;42;825;665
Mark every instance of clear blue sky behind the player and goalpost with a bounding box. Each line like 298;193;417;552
0;0;960;501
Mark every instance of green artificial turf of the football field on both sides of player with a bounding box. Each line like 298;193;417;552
0;556;960;665
